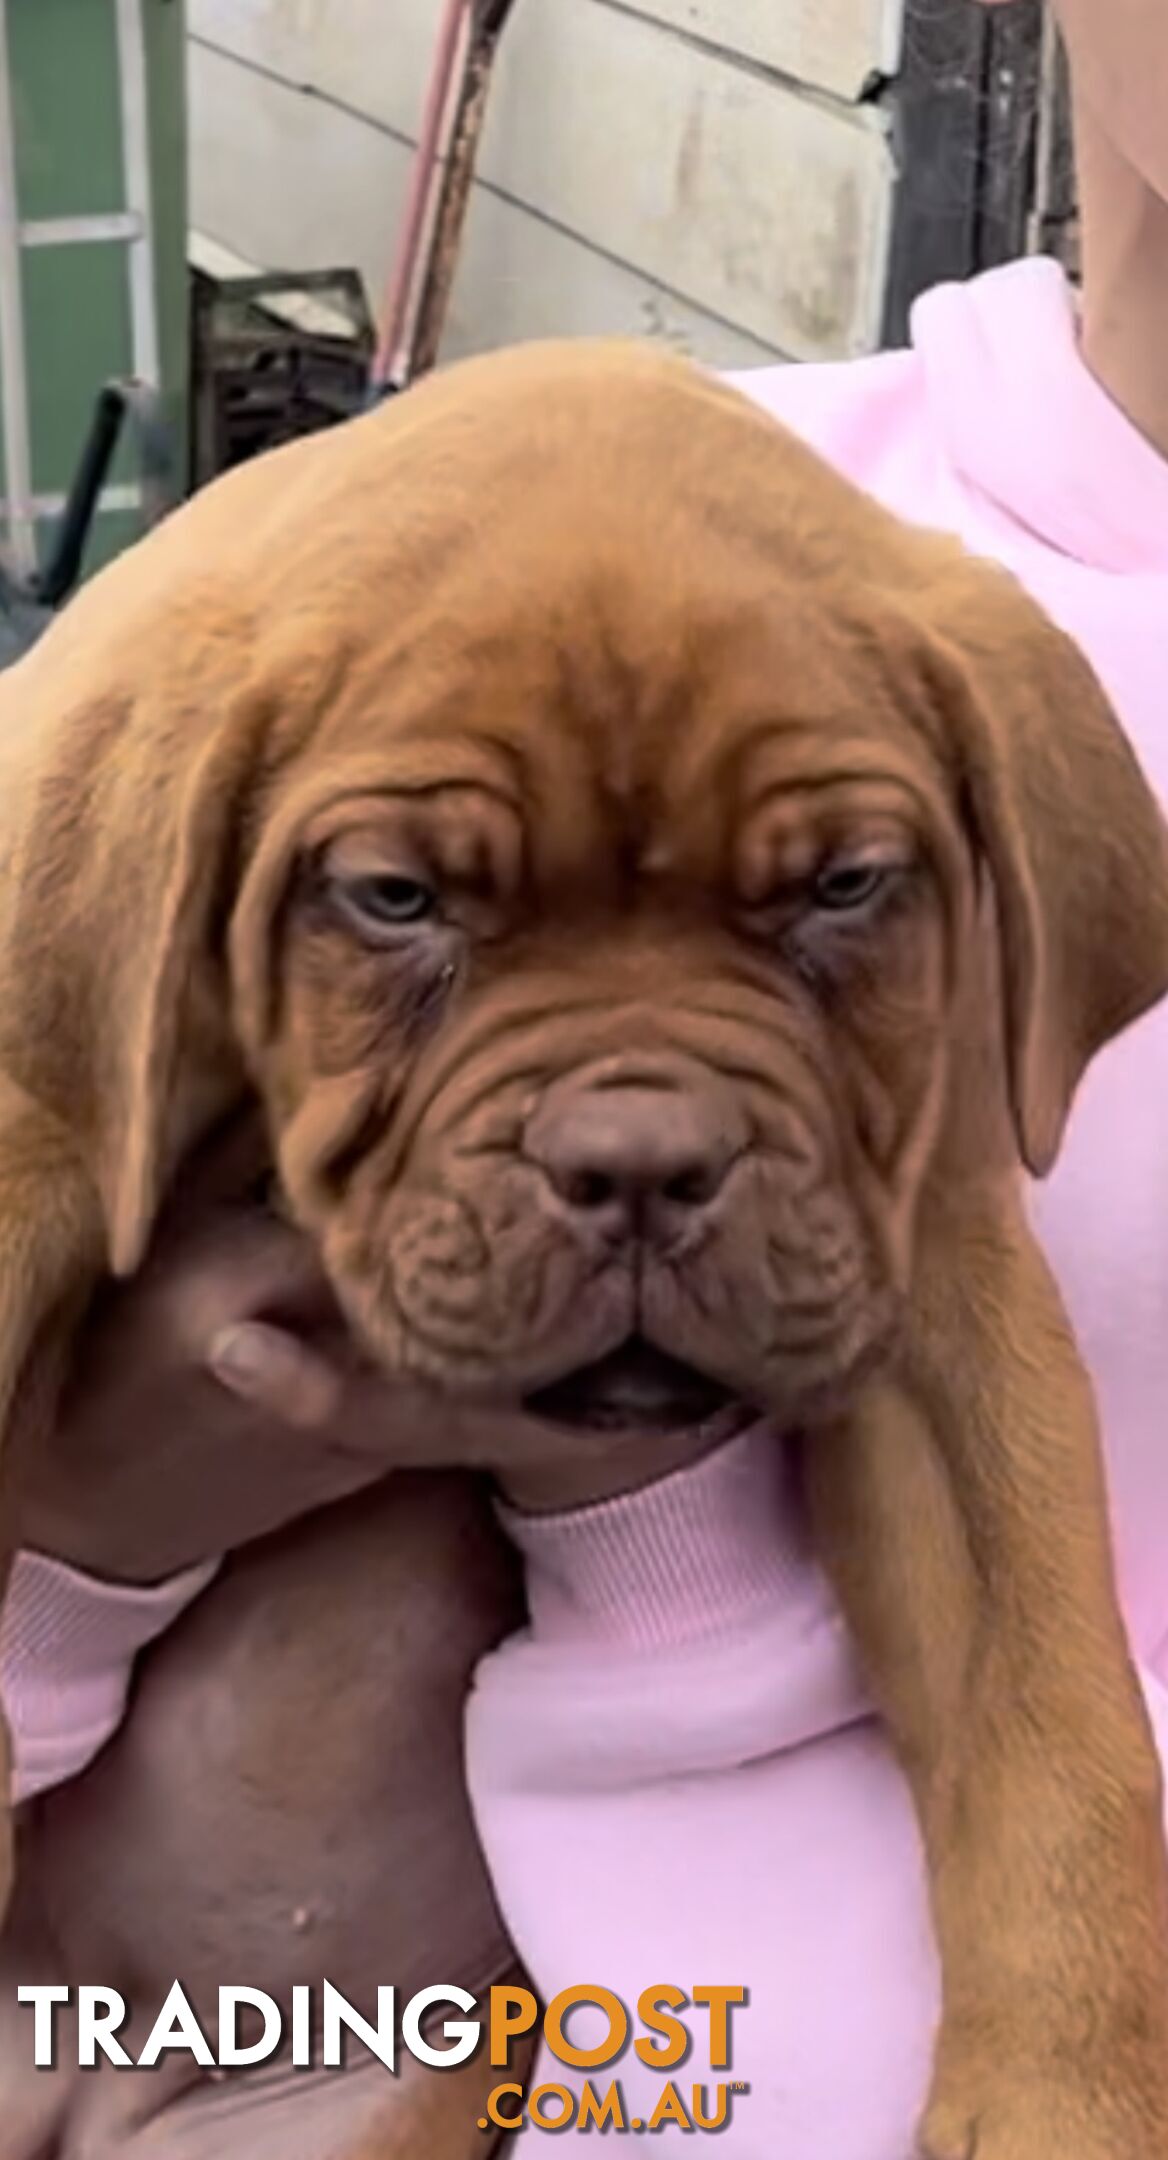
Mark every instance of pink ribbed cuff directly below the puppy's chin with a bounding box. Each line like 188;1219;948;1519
499;1426;827;1650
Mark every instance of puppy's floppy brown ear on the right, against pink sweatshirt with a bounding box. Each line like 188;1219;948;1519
926;559;1168;1177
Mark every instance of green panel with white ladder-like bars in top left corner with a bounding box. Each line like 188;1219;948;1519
0;0;188;581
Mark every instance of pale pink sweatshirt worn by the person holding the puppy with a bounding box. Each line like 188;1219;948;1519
0;261;1168;2160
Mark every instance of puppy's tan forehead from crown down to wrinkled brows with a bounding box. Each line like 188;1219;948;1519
227;352;945;864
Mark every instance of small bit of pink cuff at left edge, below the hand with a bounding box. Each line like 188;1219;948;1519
0;1553;218;1801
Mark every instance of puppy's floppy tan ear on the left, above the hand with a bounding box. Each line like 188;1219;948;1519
0;633;253;1274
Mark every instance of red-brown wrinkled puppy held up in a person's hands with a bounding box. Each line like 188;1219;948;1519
0;343;1168;2160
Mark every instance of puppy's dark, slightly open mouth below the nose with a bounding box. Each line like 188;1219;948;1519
525;1335;736;1432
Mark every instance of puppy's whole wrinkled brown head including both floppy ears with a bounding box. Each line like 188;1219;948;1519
9;348;1168;1426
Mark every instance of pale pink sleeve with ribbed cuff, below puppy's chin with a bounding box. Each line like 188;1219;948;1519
466;1428;1168;2160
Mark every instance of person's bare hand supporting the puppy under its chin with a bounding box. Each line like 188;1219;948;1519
17;1134;729;1583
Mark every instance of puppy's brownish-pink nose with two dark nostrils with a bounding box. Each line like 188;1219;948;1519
527;1080;736;1238
